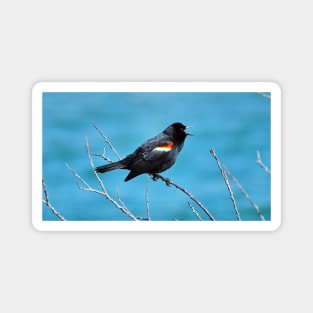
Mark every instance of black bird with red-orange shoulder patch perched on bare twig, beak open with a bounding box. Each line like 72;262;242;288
95;123;191;181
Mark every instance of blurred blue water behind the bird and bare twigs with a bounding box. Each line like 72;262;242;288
42;93;271;221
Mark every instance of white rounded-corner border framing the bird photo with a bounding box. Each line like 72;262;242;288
32;82;281;231
